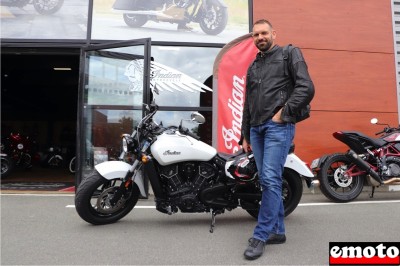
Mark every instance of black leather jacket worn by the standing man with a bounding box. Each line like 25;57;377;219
242;45;314;143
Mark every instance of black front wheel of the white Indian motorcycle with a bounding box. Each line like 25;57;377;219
75;171;140;225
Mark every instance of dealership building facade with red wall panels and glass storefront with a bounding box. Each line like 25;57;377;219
1;0;400;186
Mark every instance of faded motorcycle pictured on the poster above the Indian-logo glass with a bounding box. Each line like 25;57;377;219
113;0;228;35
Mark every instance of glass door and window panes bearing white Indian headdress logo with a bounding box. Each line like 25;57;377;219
78;41;220;183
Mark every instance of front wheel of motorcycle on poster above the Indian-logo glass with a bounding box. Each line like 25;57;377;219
199;5;228;35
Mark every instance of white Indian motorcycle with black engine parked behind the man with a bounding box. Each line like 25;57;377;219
75;101;313;232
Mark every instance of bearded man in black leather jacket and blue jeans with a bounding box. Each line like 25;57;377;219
242;19;314;260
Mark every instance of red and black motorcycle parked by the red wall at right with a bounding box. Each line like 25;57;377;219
311;118;400;202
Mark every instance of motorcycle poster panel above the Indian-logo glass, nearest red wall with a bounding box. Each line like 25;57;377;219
92;0;249;43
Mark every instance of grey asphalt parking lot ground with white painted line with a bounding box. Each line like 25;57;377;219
1;192;400;265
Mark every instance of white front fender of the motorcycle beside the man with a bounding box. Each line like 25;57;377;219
94;161;147;197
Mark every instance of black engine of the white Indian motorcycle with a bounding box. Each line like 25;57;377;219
160;162;218;212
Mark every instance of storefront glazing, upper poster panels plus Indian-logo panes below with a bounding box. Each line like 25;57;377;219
0;0;247;187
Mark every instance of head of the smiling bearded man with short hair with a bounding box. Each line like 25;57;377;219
252;19;276;52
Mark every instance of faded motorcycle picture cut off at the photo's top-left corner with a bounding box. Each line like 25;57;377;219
0;0;64;15
